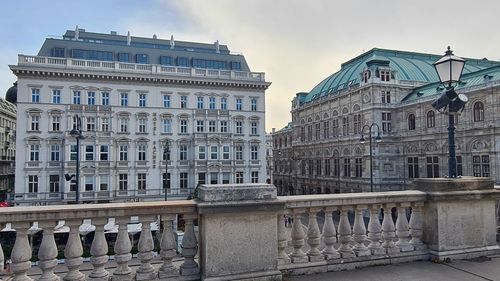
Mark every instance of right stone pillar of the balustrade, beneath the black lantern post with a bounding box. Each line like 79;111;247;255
414;177;500;259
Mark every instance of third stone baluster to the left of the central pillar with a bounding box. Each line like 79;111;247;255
135;216;156;281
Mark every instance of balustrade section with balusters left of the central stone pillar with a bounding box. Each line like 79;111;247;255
0;200;199;281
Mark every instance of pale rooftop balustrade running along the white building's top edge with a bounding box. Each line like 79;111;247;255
18;55;265;82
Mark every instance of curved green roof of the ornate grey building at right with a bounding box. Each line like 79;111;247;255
302;49;499;103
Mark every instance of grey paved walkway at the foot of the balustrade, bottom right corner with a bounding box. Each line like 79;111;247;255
284;255;500;281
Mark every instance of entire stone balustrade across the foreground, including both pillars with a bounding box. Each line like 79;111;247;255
0;178;500;280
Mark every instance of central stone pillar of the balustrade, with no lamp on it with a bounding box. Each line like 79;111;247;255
197;184;284;281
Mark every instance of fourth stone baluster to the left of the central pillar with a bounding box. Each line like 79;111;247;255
112;217;133;281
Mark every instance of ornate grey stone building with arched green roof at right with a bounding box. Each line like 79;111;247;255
273;49;500;194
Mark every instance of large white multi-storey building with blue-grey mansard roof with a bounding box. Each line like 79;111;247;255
10;28;270;204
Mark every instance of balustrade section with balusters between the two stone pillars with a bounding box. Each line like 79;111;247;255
278;191;427;272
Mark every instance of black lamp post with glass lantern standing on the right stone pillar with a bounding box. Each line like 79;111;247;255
432;46;468;178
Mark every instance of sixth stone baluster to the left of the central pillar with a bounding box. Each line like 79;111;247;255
63;220;85;281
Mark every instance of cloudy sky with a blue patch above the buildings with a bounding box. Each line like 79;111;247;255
0;0;500;131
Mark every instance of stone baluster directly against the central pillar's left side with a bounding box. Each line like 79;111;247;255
180;214;200;275
